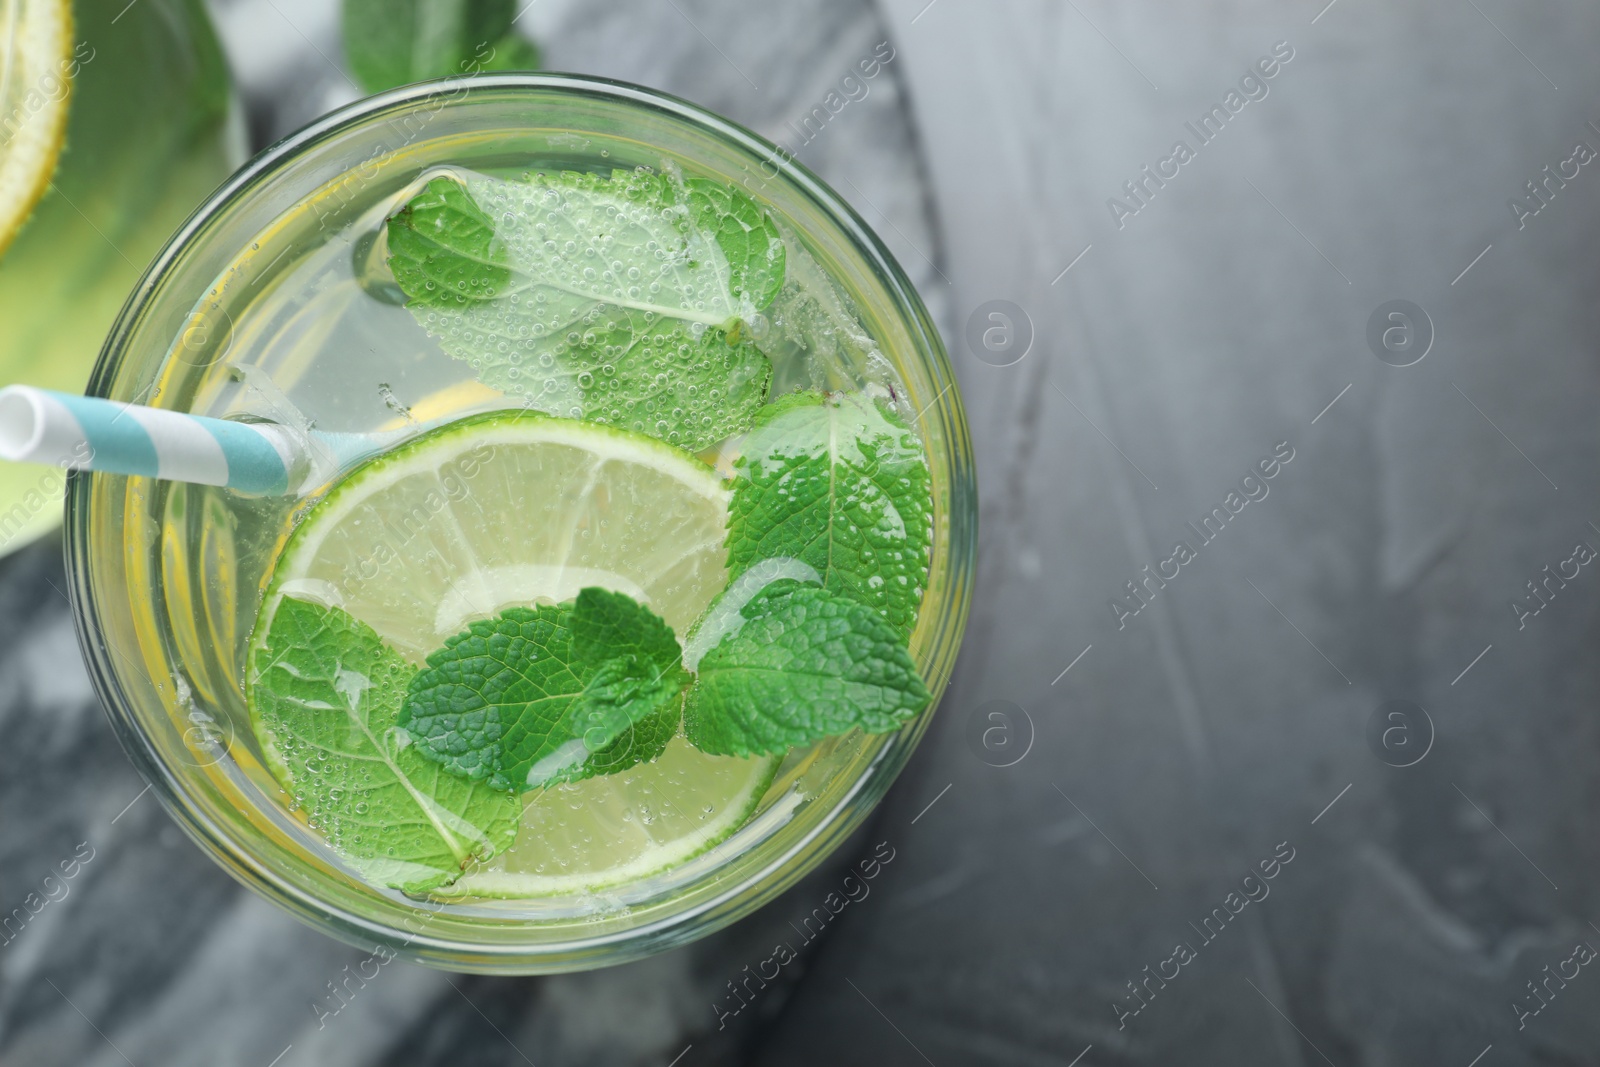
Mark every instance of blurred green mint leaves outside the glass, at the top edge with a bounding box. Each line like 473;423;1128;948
342;0;539;93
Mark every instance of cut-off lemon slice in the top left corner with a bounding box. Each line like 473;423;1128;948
0;0;72;253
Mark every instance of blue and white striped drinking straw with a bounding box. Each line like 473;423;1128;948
0;386;387;496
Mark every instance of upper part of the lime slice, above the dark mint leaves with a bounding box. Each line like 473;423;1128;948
256;411;728;662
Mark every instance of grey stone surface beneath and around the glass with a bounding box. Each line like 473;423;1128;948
0;0;1600;1067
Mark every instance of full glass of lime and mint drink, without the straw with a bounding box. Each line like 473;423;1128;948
67;75;976;973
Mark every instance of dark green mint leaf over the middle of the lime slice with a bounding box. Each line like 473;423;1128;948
400;589;688;790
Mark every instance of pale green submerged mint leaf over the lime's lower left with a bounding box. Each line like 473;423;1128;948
250;597;522;893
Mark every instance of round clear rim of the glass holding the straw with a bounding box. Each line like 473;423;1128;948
64;72;978;974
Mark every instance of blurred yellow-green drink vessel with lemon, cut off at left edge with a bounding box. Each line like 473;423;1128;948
0;0;245;552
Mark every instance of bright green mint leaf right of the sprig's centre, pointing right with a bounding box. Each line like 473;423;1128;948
683;579;933;755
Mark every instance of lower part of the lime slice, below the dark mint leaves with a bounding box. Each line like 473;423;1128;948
434;737;779;897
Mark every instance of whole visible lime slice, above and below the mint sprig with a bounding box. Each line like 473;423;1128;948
253;411;778;897
